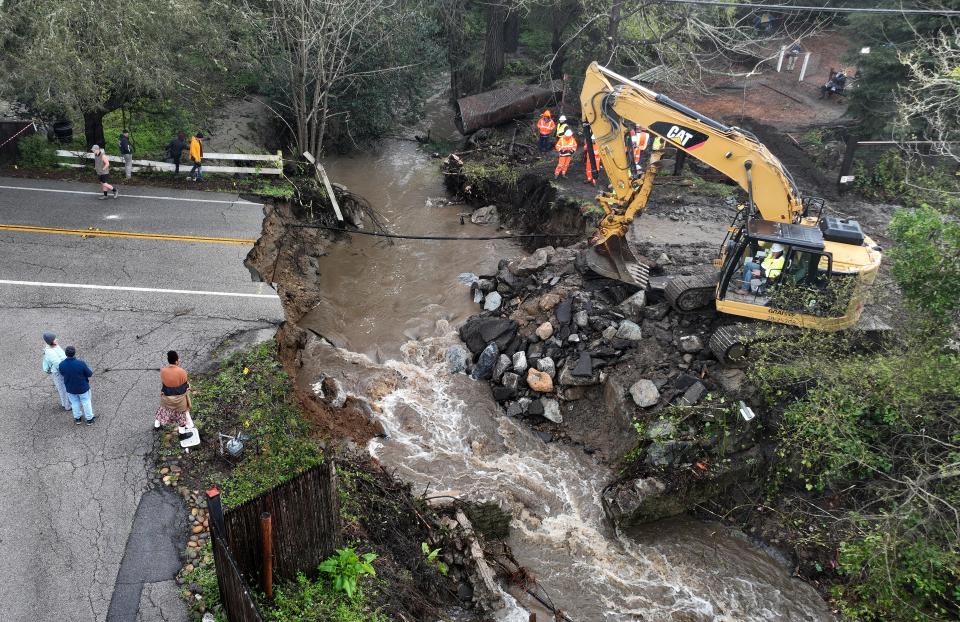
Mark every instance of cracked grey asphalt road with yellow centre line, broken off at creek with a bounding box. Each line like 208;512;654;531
0;178;282;622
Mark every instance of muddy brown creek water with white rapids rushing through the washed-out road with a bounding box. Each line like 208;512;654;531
300;94;831;622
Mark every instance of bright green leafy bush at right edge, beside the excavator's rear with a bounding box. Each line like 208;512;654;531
888;205;960;321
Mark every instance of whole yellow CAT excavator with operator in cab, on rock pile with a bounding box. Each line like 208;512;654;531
580;63;881;364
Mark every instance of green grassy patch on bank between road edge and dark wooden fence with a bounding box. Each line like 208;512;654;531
192;341;324;507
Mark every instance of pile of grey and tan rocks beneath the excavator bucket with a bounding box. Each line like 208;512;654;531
447;244;756;482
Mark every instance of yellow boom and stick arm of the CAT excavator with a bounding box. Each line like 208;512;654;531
580;63;803;274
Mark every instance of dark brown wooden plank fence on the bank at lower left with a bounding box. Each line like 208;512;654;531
207;460;340;622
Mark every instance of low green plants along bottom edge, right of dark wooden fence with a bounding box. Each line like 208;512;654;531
260;573;387;622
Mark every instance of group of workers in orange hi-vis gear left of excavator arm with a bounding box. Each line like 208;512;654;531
537;110;663;186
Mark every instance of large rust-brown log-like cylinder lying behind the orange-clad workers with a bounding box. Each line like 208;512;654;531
454;81;561;134
